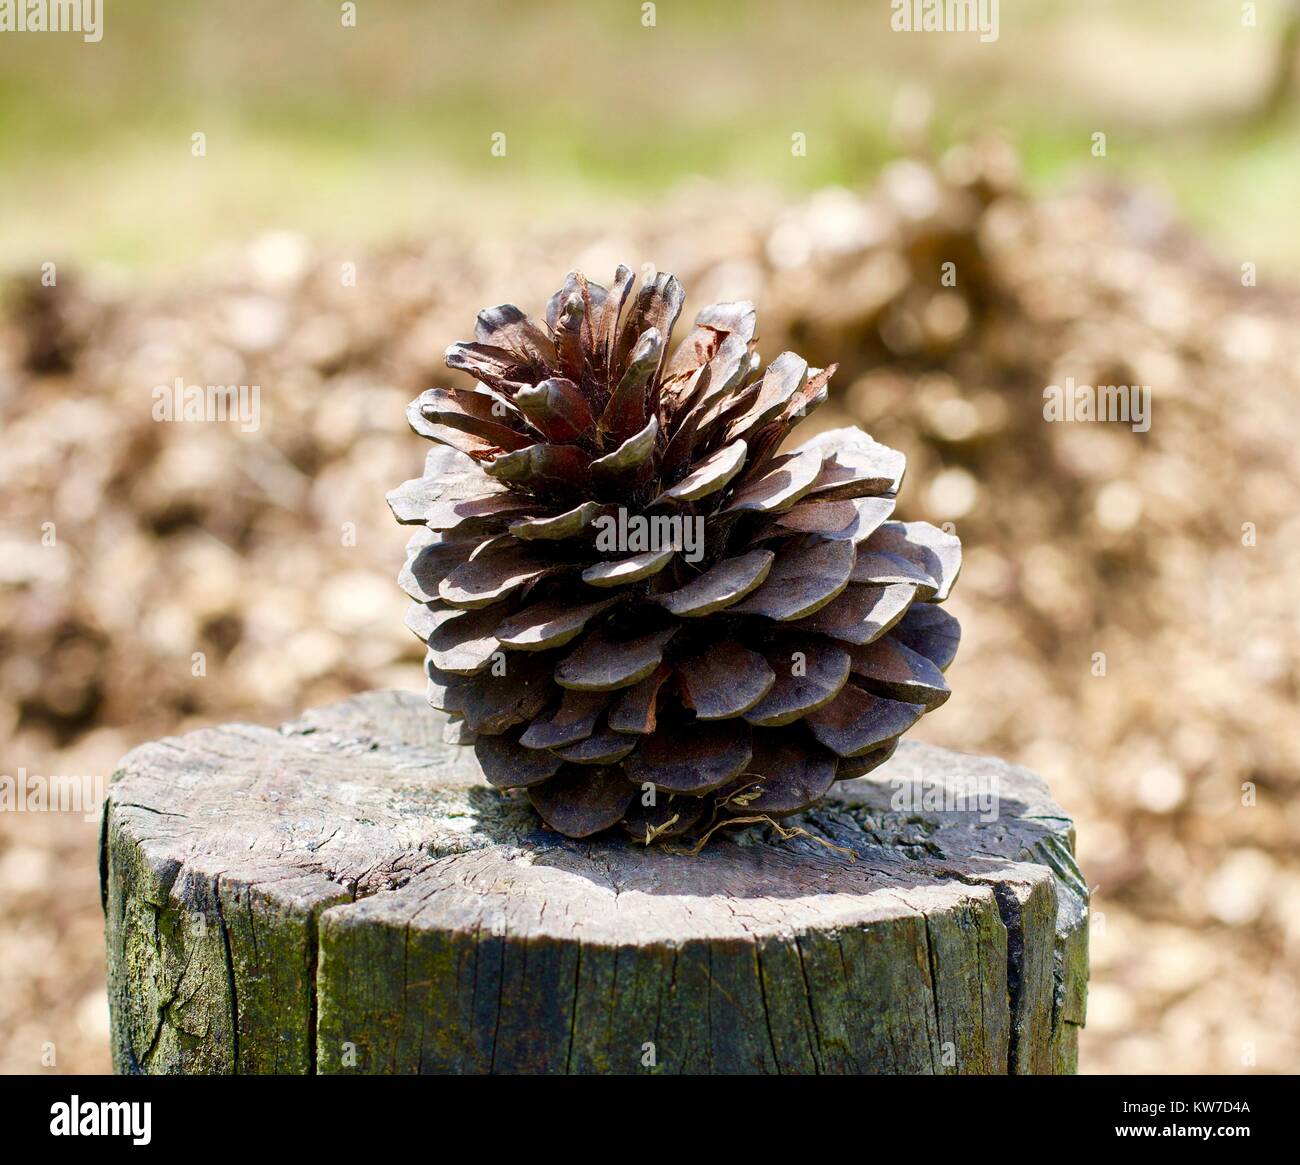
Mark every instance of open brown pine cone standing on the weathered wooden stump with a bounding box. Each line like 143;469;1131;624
389;267;961;843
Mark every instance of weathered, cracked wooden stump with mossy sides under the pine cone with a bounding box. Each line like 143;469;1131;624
101;692;1087;1073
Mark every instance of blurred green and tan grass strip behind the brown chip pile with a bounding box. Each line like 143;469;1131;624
0;0;1300;277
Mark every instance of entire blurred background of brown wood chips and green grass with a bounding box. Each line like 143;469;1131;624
0;0;1300;1074
